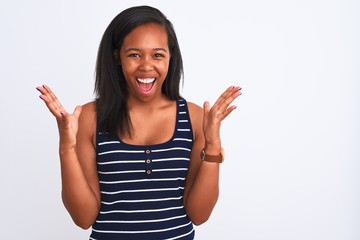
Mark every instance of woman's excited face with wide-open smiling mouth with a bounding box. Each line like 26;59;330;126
119;23;170;101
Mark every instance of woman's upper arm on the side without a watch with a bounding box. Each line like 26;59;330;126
76;102;101;206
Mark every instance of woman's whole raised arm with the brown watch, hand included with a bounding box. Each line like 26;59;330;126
184;87;241;225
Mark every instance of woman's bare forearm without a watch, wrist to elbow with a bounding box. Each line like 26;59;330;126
59;147;100;229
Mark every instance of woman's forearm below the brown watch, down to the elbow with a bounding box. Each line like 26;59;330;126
185;161;220;225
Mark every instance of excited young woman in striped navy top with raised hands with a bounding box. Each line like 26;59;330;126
37;6;241;240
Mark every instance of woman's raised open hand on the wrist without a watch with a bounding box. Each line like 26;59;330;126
36;85;82;150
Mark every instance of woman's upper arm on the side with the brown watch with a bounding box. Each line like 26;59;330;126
183;102;205;205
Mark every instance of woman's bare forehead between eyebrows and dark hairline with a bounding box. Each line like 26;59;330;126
122;23;168;48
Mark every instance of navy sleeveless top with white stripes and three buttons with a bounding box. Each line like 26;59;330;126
90;99;195;240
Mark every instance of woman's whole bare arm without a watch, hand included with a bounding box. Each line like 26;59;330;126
37;86;100;229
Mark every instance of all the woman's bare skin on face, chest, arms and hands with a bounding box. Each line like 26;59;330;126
37;23;241;229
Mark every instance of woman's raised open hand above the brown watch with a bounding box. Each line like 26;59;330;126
203;86;241;155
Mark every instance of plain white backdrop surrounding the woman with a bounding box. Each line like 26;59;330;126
0;0;360;240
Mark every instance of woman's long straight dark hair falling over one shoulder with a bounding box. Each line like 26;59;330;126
94;6;183;137
